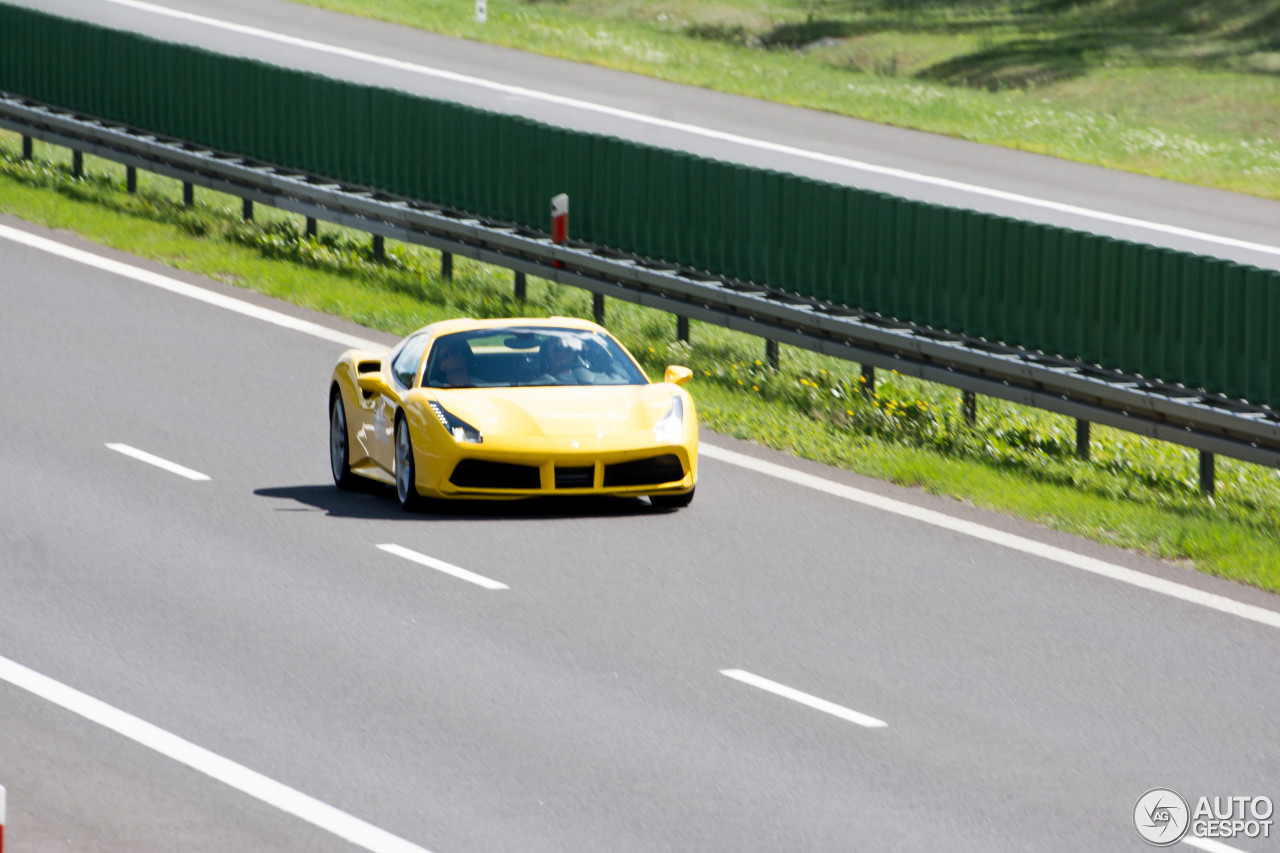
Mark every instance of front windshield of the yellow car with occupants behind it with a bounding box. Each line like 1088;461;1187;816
422;327;648;388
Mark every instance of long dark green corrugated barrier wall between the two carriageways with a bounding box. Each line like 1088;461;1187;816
0;5;1280;409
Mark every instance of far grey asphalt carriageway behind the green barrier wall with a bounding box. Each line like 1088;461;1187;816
17;0;1280;269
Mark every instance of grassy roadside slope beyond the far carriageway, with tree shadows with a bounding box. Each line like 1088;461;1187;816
285;0;1280;199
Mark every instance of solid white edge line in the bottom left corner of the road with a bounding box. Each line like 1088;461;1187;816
0;657;429;853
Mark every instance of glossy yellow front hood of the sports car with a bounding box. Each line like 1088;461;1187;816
436;383;675;438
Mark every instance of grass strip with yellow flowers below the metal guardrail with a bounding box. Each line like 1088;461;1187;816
0;133;1280;590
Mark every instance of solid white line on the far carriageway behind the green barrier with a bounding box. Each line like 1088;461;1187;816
106;0;1280;255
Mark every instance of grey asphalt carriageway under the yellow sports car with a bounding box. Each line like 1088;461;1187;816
0;217;1280;853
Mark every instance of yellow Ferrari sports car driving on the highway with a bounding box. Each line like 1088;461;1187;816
329;318;698;508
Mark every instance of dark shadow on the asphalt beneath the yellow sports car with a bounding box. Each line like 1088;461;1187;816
253;483;671;521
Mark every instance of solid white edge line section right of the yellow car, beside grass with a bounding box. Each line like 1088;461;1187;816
699;443;1280;628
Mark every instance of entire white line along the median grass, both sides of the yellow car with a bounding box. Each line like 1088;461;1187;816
0;219;1280;628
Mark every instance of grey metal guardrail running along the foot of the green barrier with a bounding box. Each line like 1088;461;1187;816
0;93;1280;481
